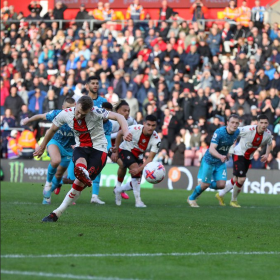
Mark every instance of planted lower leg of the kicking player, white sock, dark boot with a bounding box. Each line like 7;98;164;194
42;180;84;222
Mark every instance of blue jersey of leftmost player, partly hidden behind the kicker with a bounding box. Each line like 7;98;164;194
46;110;75;153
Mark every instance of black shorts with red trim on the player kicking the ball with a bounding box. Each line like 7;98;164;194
73;147;107;180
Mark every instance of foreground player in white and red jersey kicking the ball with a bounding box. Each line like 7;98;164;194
34;96;132;222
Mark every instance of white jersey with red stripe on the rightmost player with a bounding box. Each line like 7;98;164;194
234;125;272;159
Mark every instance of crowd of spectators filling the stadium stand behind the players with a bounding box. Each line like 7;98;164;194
0;0;280;169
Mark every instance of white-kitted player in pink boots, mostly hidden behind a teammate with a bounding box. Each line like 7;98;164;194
108;100;137;199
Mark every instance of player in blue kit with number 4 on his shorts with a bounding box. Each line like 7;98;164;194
188;114;240;207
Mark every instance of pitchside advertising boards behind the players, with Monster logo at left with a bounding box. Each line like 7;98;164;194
1;160;280;194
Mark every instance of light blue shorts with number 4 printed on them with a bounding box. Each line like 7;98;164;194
197;158;227;184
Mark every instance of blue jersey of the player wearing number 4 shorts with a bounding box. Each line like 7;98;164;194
204;126;240;165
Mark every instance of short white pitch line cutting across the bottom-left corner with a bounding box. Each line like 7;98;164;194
1;269;140;280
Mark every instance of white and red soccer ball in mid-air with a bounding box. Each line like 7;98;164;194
143;162;165;184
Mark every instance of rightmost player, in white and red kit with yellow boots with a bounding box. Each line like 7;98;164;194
215;114;272;207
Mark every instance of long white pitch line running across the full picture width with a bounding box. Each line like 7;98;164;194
1;251;280;259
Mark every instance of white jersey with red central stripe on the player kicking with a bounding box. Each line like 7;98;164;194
53;107;109;152
